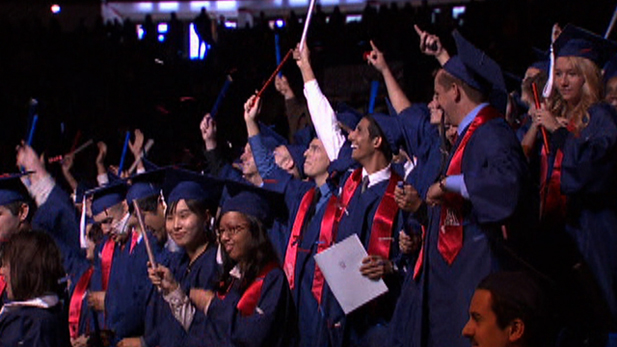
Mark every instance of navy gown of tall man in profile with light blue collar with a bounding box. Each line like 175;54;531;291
398;109;537;347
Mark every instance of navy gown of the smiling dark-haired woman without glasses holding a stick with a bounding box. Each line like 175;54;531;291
146;245;220;347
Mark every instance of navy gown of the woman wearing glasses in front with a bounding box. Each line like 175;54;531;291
187;268;298;347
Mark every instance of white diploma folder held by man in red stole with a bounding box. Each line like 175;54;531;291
315;234;388;314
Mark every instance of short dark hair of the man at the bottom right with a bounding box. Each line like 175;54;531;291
477;271;546;346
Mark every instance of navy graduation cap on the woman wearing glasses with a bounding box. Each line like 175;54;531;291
221;180;287;225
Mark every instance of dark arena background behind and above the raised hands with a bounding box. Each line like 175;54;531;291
0;0;617;186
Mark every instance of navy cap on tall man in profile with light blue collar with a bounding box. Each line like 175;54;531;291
443;30;507;112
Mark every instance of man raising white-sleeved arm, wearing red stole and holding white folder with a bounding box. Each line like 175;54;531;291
294;41;404;346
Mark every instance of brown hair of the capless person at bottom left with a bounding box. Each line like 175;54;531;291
2;231;65;301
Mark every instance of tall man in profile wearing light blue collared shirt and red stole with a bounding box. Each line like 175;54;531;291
399;32;534;346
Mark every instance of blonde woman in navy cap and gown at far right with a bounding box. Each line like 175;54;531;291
534;25;617;345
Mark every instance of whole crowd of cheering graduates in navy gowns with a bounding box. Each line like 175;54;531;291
0;2;617;347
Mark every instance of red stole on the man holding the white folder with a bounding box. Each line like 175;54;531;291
338;168;402;259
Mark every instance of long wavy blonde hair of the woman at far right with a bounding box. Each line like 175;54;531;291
547;57;602;133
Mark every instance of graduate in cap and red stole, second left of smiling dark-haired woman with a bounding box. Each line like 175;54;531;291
87;181;148;343
